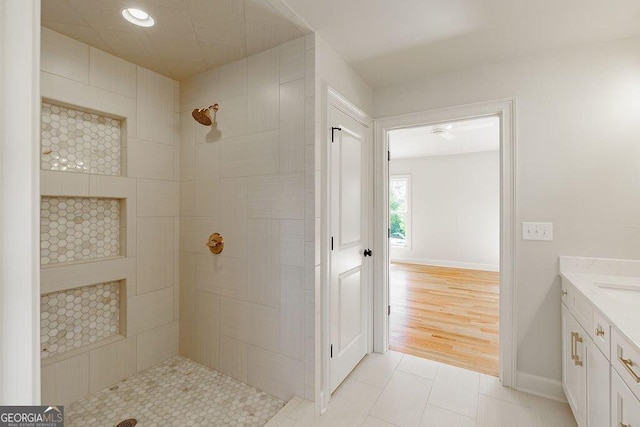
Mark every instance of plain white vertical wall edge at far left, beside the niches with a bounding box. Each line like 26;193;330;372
0;0;40;405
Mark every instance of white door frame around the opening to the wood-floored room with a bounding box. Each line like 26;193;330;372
373;98;517;388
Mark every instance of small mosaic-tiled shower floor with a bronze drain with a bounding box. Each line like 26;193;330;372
65;356;284;427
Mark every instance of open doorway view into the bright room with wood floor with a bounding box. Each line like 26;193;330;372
389;116;500;376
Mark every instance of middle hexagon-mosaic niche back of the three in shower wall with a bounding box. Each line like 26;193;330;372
40;197;121;265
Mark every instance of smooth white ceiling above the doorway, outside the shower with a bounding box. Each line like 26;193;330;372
286;0;640;88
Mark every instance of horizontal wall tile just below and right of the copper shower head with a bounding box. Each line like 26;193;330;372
220;131;280;177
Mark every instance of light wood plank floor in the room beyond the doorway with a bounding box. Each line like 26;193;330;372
389;263;500;376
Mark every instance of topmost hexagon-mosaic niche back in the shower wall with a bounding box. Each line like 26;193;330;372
40;102;122;175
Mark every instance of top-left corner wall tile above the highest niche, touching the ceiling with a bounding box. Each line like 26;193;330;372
40;27;89;84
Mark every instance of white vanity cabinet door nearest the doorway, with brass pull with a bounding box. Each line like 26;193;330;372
562;304;587;427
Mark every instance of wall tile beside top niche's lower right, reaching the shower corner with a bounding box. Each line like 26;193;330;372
127;139;174;181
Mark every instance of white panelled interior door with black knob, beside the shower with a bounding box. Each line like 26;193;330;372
329;107;371;392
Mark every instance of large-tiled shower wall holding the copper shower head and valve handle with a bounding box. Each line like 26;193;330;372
180;37;314;400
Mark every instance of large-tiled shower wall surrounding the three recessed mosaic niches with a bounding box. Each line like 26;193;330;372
36;28;179;404
